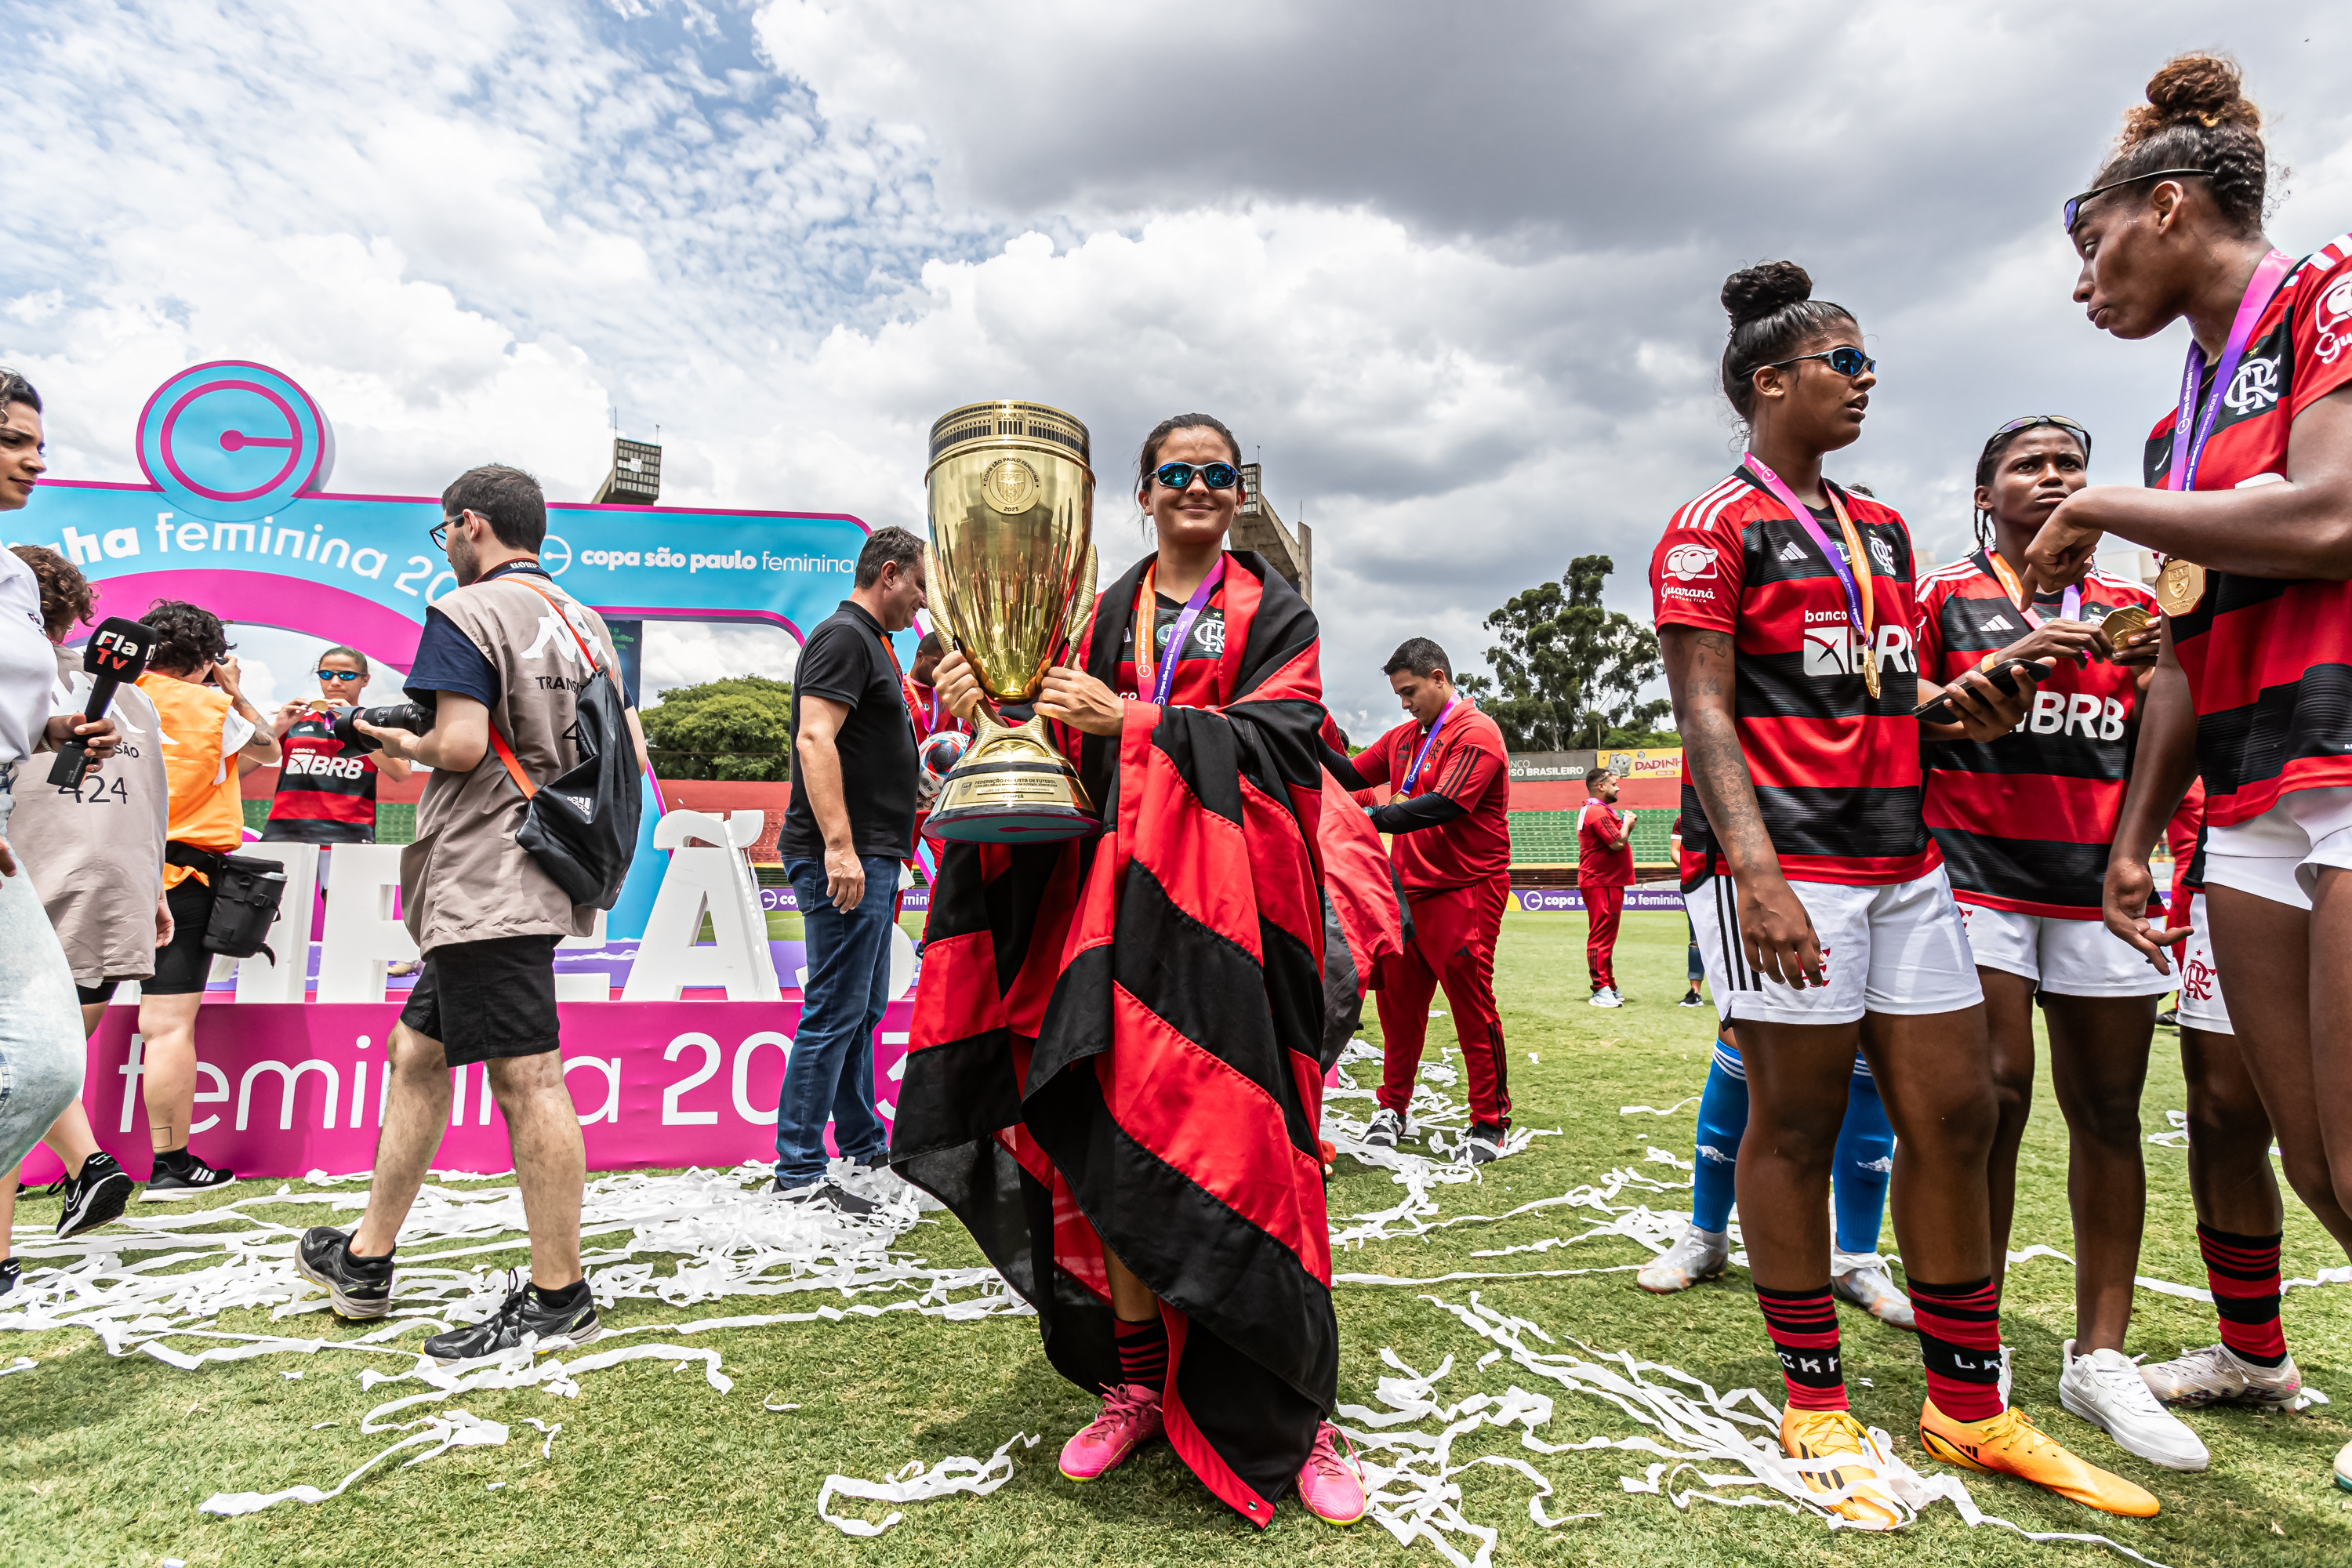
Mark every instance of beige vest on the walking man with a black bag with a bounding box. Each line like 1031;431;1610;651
400;576;626;952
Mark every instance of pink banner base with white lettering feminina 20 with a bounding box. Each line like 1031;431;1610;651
24;994;913;1182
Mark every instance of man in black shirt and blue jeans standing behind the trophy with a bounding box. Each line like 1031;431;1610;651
776;529;922;1213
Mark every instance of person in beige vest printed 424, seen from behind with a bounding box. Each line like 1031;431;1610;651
0;546;172;1258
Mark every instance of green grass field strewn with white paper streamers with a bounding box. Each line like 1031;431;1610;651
0;914;2352;1568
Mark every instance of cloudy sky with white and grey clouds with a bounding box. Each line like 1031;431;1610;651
0;0;2352;727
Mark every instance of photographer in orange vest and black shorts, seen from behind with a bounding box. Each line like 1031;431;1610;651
139;600;278;1201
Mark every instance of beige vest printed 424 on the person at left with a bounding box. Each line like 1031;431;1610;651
9;649;172;985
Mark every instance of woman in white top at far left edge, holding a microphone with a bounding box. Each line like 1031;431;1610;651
0;369;115;1203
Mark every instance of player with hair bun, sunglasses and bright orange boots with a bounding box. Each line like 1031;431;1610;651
1651;261;2157;1530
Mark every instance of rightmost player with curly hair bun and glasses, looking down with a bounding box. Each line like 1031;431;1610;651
2027;54;2352;1486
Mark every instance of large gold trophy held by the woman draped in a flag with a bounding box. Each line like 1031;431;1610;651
924;402;1103;844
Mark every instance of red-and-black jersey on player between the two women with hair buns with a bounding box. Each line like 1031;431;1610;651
1915;550;2157;919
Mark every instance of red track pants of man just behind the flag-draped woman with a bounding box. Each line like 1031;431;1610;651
1374;874;1510;1126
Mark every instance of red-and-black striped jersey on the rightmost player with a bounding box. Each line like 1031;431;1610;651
2147;235;2352;827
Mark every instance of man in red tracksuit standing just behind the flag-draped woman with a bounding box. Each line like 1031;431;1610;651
1324;637;1510;1163
